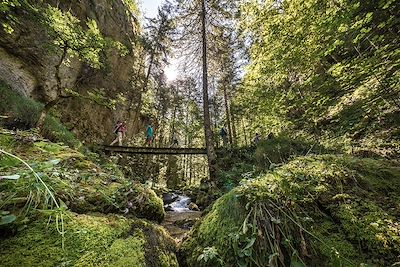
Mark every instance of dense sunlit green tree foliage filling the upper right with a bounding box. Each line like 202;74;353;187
236;0;400;157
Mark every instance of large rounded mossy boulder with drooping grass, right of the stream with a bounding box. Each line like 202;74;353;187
180;155;400;266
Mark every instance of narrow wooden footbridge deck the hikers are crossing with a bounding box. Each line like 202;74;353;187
104;146;207;155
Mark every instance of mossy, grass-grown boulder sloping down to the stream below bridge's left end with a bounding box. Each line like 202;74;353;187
0;129;165;222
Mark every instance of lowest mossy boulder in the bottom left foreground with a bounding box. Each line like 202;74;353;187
0;211;178;267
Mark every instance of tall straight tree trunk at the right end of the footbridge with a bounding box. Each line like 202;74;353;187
201;0;217;181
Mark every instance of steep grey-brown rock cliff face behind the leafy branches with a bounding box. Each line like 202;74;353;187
0;0;144;142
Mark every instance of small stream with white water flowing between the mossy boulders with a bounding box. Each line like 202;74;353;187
162;193;201;244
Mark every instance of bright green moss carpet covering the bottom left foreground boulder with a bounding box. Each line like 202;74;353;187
0;213;129;266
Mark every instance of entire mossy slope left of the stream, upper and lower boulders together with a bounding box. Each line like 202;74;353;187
0;129;178;267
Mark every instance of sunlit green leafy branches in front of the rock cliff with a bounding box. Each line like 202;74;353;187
0;0;128;68
